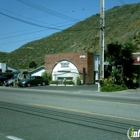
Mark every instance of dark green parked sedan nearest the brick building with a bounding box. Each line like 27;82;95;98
18;76;48;87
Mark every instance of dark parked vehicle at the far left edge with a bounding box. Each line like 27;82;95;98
0;73;14;86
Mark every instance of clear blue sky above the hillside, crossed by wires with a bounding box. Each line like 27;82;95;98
0;0;140;52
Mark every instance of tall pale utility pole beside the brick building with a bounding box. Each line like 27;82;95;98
98;0;105;91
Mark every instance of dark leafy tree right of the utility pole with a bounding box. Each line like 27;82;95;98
105;42;136;85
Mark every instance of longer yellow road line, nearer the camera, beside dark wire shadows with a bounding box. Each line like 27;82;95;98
26;103;140;122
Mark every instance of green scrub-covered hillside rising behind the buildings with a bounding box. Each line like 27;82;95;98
0;3;140;68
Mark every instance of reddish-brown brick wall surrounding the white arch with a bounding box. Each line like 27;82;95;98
45;52;94;83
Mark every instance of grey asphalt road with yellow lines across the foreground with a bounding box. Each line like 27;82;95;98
0;85;140;140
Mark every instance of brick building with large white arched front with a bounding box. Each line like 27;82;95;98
45;52;98;84
